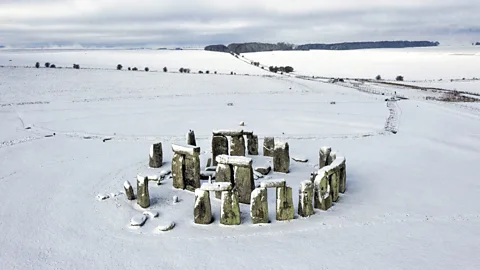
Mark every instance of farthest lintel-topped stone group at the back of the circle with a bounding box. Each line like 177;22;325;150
212;130;258;165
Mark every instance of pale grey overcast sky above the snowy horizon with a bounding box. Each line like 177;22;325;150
0;0;480;46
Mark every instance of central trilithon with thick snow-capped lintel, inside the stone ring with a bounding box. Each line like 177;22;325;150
216;155;255;204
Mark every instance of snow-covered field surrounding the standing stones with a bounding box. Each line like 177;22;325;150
0;48;480;269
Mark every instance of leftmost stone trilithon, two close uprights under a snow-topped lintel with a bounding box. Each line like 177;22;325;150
172;144;200;192
